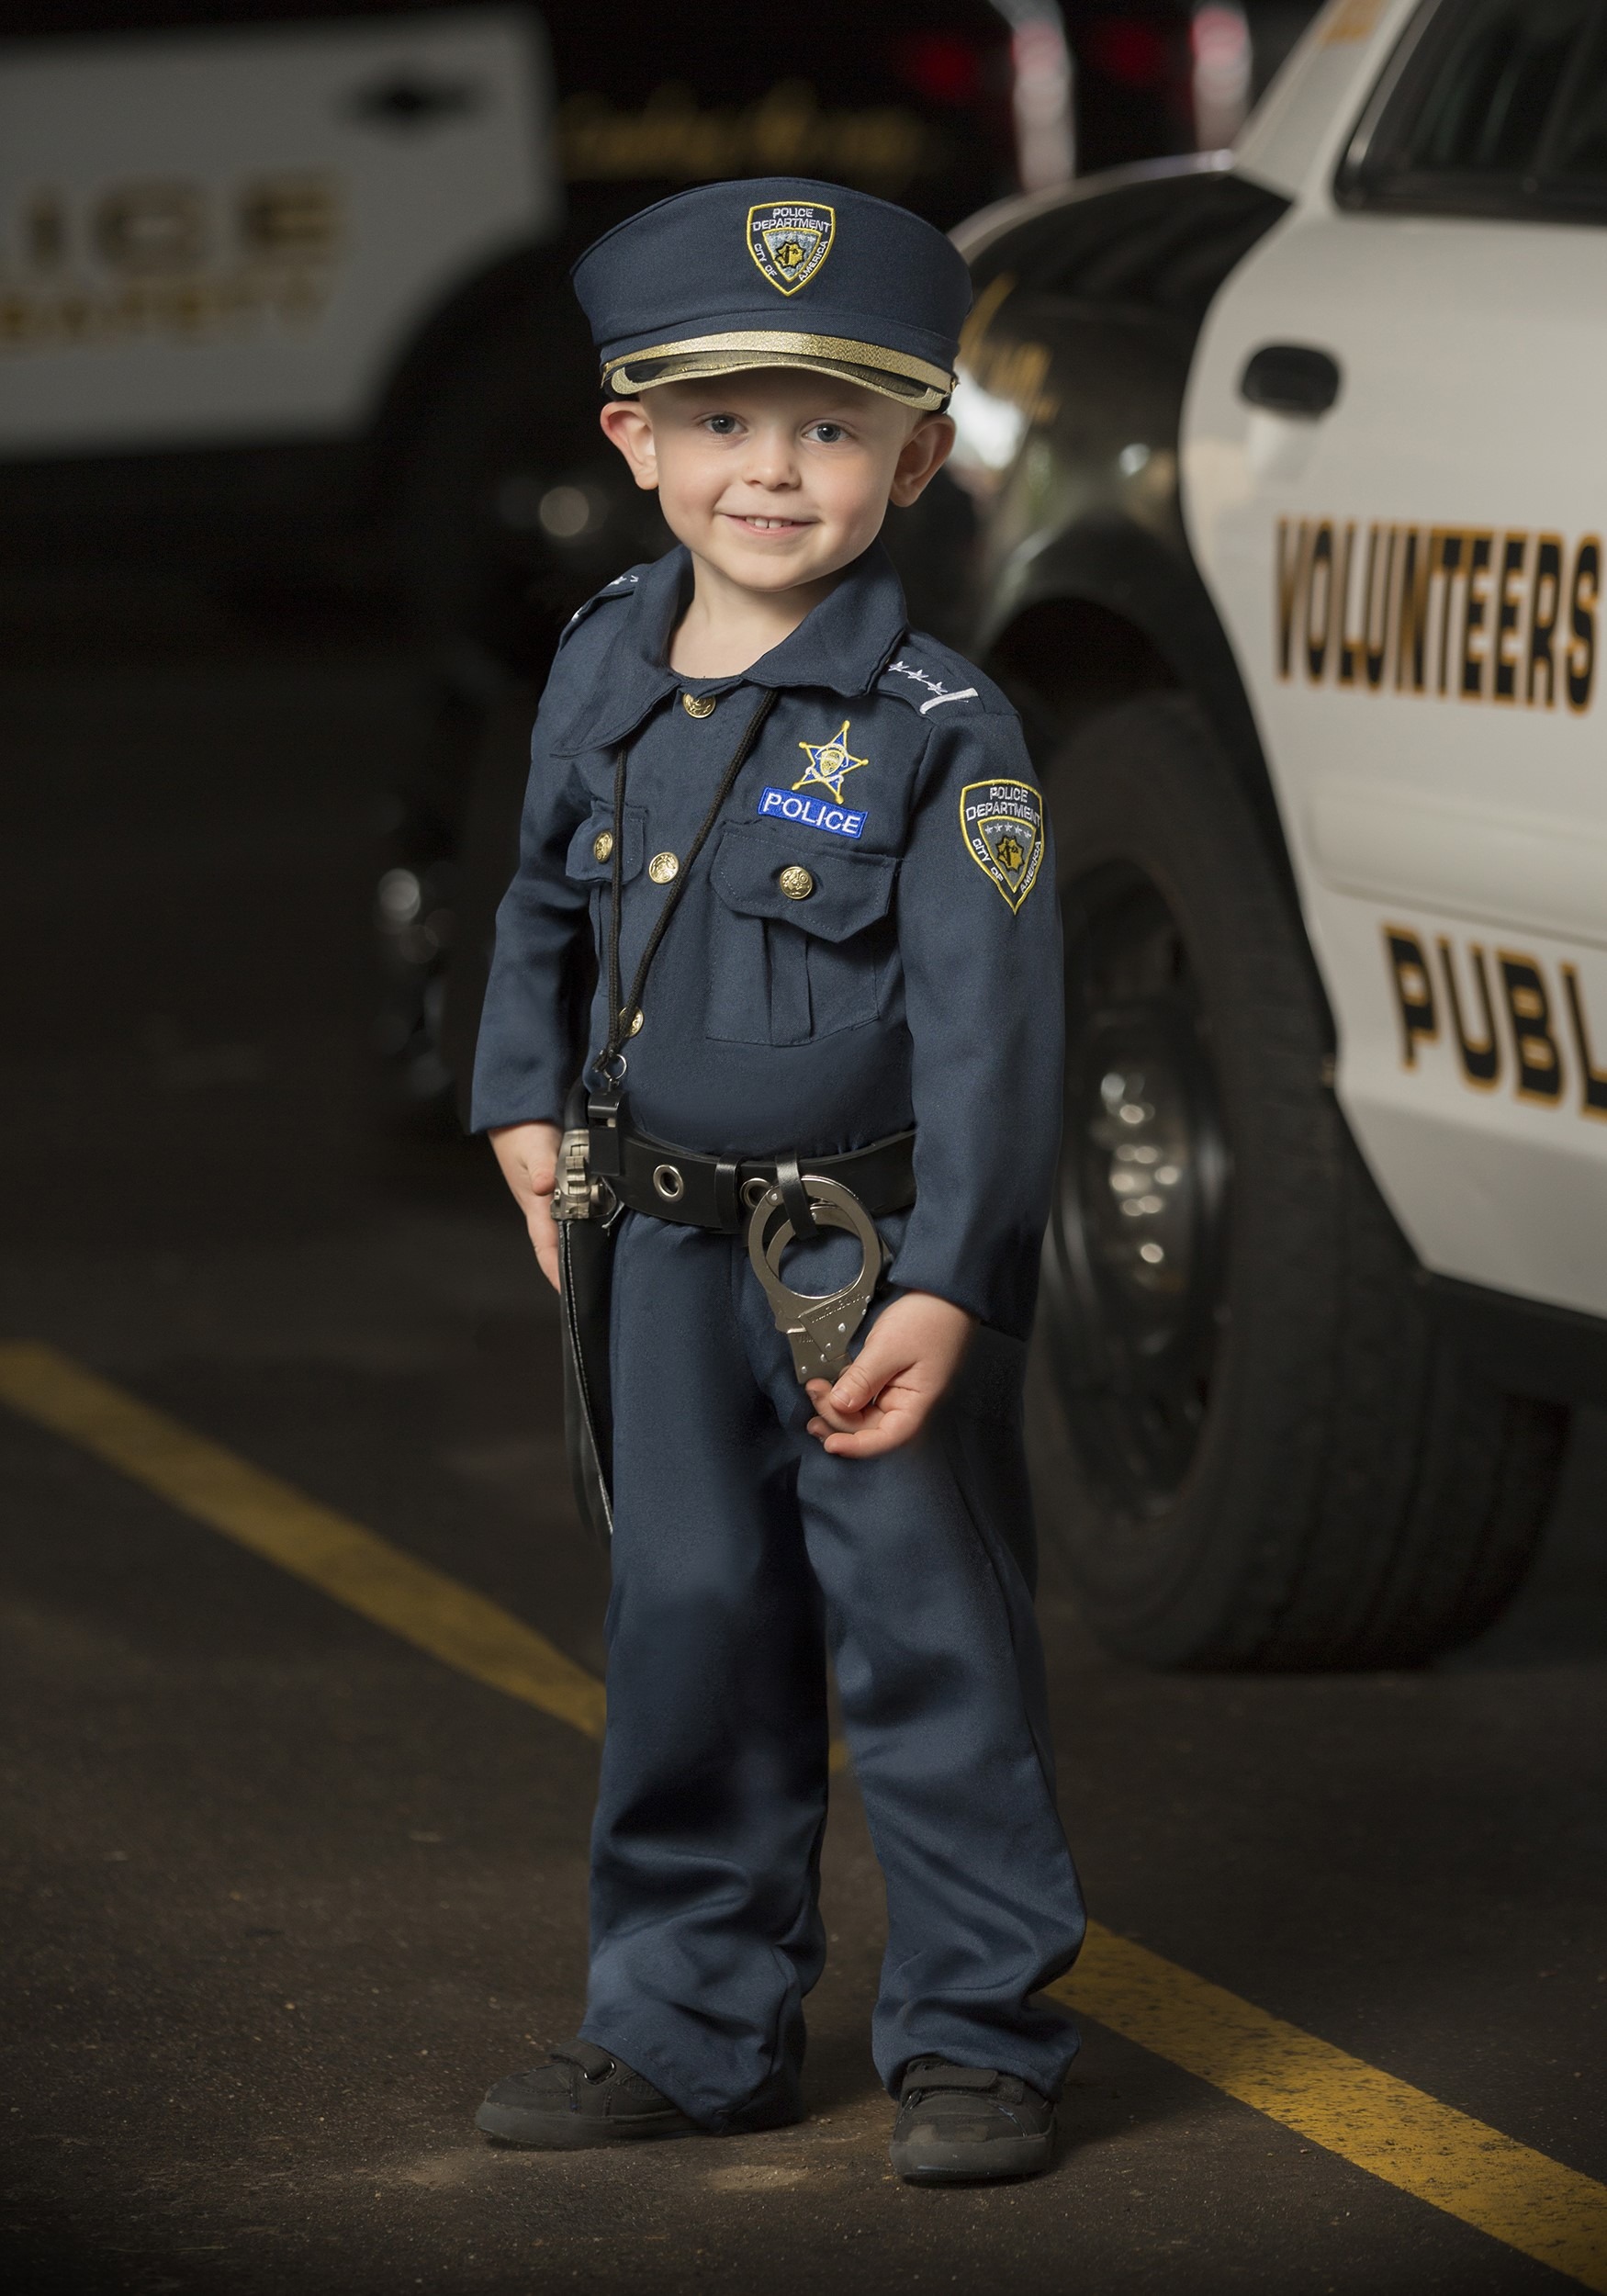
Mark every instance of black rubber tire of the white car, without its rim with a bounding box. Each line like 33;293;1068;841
1033;696;1568;1670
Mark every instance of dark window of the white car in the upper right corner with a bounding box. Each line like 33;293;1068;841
1336;0;1607;220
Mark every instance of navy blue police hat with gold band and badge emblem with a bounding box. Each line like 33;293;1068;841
569;177;972;411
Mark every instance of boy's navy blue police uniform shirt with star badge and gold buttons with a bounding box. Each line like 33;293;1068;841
473;545;1063;1336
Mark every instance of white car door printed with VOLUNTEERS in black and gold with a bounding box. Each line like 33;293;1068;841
1183;0;1607;1313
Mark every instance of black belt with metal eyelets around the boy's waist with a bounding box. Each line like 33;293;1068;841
592;1128;916;1235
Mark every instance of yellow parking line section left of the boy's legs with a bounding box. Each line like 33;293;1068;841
0;1344;604;1739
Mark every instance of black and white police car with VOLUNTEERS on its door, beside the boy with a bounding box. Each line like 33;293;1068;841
958;0;1607;1667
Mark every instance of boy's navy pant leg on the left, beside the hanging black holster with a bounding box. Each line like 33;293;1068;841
583;1217;826;2129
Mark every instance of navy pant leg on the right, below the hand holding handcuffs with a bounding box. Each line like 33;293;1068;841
744;1240;1084;2097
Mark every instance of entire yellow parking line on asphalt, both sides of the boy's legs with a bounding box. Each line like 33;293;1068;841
0;1344;1607;2296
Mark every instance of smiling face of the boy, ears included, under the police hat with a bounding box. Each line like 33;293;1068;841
601;367;955;592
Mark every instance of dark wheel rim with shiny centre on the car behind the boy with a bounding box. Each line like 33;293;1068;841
1045;866;1231;1525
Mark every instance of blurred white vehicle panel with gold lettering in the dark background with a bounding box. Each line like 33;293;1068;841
0;9;560;457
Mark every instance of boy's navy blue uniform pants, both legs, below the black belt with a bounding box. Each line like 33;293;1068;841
571;1215;1084;2131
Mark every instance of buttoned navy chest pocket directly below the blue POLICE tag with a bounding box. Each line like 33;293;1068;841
707;822;898;1045
